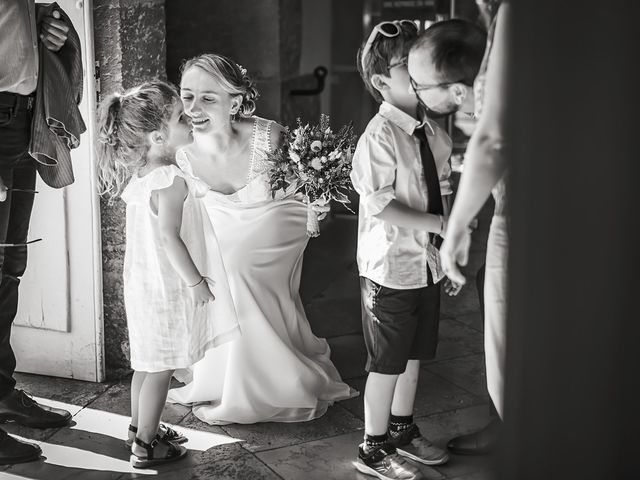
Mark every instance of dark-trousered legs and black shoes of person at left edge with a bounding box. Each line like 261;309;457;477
0;92;71;464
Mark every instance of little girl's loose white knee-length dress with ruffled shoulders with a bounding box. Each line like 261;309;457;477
122;165;240;372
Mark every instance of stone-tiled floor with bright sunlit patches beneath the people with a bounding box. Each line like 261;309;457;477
0;215;491;480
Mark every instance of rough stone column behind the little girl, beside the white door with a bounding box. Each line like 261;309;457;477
93;0;166;378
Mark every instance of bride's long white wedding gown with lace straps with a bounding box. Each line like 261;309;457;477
169;118;357;424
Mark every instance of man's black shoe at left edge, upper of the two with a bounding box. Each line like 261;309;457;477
0;390;71;428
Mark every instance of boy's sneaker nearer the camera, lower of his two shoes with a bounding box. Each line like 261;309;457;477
356;444;425;480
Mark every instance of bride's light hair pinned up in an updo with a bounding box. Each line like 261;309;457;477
180;53;259;117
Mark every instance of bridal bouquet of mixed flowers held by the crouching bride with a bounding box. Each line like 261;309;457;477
269;114;355;237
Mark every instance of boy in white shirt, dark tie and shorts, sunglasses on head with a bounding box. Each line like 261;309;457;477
351;20;452;479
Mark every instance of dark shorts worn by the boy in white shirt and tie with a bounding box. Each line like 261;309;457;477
360;277;440;375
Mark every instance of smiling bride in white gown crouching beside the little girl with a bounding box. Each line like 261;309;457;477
169;55;355;424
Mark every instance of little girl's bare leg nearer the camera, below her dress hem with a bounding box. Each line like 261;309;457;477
132;370;173;456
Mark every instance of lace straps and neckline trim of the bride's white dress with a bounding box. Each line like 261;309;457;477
176;117;283;205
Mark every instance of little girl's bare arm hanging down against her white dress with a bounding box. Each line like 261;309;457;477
155;177;213;305
